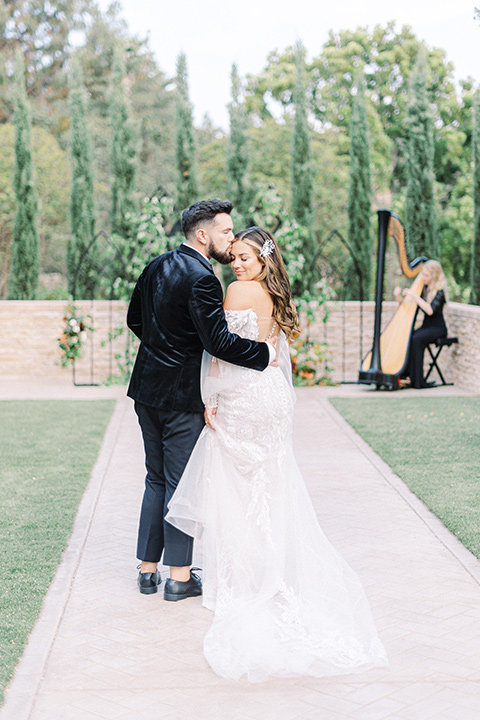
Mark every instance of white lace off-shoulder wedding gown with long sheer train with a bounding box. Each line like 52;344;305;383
167;310;387;681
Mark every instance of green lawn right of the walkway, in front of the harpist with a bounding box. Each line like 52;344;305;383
331;395;480;558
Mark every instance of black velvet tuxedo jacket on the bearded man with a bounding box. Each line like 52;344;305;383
127;245;269;412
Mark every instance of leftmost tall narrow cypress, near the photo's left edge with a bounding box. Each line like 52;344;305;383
9;49;39;300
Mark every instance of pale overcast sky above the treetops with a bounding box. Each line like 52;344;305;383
98;0;480;129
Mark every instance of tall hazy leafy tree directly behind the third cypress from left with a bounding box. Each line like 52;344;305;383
77;3;176;228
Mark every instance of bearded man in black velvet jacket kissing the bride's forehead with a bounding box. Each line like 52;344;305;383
127;200;275;601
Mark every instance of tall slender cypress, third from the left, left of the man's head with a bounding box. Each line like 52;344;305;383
110;47;138;238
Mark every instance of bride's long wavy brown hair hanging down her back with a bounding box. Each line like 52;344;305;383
233;225;300;339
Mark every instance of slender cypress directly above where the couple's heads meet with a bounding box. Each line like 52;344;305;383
227;63;249;222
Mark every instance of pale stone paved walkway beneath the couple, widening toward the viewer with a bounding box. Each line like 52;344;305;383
0;383;480;720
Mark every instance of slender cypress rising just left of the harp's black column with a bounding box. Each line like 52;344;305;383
346;78;373;300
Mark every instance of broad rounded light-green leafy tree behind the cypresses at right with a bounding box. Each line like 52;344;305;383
246;22;462;191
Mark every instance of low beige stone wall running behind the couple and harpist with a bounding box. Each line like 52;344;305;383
0;300;480;392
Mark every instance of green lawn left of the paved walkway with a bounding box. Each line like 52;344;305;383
0;400;115;702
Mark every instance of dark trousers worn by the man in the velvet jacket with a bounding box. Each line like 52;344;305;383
135;402;205;567
